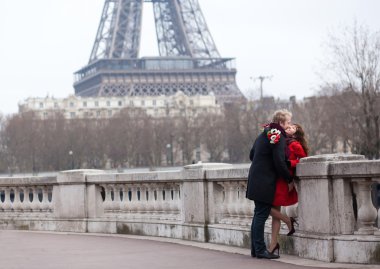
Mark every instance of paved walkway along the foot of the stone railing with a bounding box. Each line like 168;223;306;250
0;231;380;269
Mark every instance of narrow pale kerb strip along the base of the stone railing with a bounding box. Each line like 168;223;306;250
4;230;380;269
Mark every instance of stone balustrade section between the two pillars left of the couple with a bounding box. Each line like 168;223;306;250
87;173;181;221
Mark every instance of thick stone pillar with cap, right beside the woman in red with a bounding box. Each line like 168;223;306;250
297;154;364;235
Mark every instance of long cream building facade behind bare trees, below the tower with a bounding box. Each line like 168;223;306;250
19;92;221;119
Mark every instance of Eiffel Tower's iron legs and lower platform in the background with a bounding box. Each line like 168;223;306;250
74;0;243;102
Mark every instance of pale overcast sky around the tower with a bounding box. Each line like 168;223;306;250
0;0;380;114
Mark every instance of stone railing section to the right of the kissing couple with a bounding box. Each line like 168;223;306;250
293;155;380;263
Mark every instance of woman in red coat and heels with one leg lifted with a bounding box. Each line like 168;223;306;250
269;124;308;253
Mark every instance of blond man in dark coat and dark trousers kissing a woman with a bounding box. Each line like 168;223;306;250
246;110;294;259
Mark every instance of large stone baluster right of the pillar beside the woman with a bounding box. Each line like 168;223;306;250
353;179;377;235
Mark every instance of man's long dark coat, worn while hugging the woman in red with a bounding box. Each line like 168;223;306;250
246;124;293;204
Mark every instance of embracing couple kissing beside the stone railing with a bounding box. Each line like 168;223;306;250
246;110;308;259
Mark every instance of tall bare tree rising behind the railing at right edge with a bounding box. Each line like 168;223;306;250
324;24;380;158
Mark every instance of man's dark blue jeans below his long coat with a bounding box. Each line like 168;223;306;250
251;201;272;253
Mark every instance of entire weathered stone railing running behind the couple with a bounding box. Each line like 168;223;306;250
0;155;380;263
